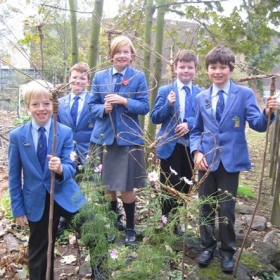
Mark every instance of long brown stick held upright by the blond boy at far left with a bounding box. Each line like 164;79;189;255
46;89;59;280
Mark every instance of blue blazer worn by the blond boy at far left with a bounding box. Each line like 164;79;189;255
8;121;86;222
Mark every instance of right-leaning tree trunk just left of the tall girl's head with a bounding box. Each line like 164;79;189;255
88;0;103;79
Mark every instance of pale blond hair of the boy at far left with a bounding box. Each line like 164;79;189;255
22;80;53;108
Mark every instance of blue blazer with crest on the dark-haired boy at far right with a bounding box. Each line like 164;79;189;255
190;82;275;172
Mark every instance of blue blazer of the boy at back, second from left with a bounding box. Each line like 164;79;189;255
57;93;95;165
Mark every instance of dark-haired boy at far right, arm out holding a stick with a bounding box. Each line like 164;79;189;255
190;45;277;272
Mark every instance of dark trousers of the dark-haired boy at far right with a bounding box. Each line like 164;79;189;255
198;163;239;256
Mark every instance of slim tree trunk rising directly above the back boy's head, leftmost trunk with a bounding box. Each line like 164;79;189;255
69;0;79;65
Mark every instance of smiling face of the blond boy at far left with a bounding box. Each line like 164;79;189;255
28;96;53;126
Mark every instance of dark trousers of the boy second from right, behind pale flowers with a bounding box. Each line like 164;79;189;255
160;143;193;215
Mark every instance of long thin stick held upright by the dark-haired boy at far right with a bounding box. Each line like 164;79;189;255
233;76;276;277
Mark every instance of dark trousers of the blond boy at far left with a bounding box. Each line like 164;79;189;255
28;194;80;280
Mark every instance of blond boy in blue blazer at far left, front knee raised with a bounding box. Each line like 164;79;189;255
8;80;89;280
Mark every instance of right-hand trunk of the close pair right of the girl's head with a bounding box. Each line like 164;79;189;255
147;0;166;140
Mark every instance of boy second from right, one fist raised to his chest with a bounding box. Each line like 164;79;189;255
151;50;201;234
